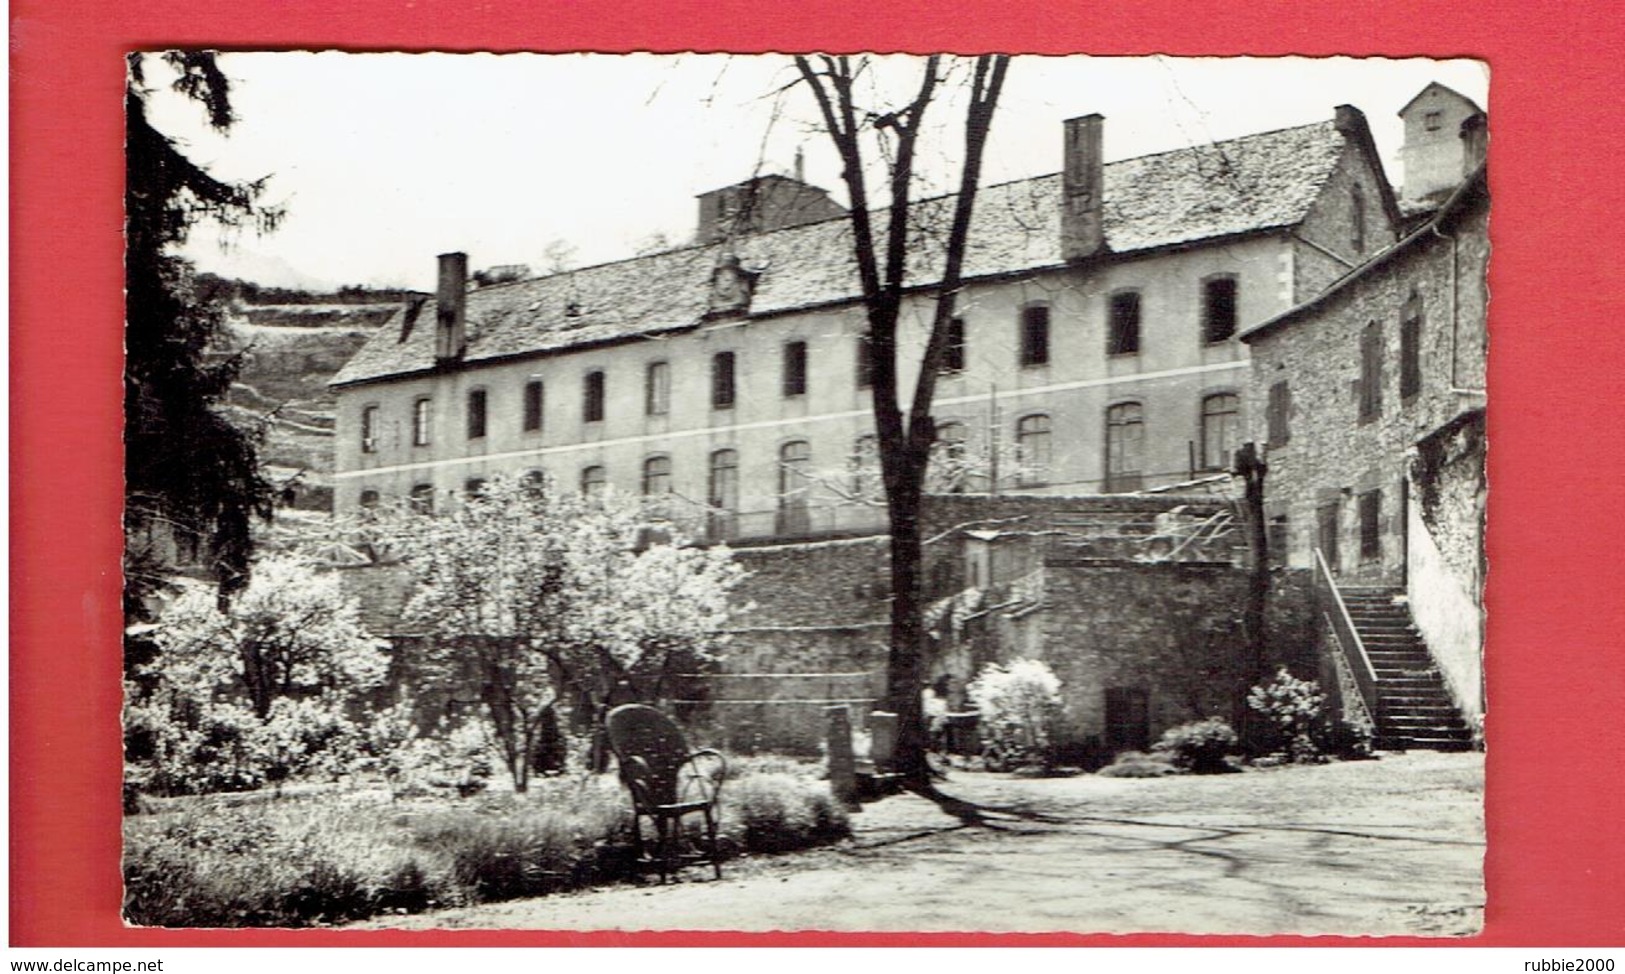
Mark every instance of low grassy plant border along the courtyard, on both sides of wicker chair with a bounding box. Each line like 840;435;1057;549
124;764;850;927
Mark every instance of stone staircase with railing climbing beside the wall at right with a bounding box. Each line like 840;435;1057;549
1337;585;1472;751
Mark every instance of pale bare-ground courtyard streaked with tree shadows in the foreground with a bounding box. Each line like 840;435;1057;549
364;751;1484;937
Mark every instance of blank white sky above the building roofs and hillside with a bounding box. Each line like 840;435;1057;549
150;52;1489;291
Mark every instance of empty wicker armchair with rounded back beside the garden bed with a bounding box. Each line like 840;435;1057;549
605;704;728;883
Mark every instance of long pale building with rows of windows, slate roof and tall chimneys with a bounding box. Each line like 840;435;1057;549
333;106;1399;540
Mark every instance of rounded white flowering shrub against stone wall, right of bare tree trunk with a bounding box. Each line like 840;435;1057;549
965;660;1061;769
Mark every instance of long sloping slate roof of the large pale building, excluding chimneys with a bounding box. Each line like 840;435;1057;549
332;120;1346;385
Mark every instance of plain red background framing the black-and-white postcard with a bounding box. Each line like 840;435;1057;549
10;0;1625;946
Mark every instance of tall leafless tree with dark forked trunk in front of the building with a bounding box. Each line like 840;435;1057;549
796;54;1009;789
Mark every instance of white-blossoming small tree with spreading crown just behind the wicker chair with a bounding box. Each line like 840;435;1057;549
385;478;744;792
